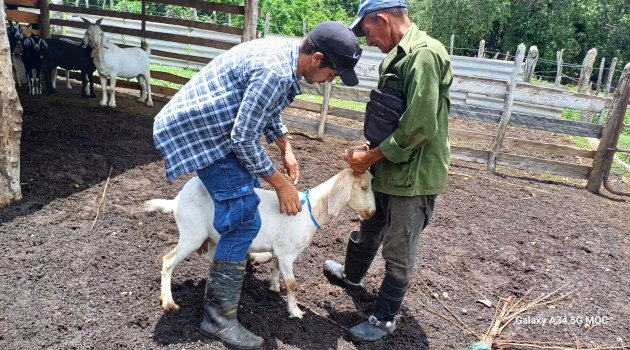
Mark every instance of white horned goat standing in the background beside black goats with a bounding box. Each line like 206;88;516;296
81;17;153;107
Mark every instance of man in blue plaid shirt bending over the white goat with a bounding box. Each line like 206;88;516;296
153;22;361;349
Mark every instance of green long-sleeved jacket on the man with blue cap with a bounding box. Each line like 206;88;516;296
373;24;453;196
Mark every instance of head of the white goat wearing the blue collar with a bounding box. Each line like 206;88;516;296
328;168;376;219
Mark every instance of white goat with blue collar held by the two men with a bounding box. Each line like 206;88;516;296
144;169;375;318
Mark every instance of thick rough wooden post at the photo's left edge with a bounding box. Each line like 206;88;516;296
0;6;23;208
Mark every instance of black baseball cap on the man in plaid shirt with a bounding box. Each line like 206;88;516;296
308;21;362;86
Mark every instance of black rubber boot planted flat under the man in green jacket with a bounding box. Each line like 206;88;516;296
346;275;408;343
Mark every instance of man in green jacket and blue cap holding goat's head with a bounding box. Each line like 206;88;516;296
324;0;453;342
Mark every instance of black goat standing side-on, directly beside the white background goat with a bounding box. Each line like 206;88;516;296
43;39;96;97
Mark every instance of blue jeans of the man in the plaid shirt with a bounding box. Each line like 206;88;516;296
197;153;261;262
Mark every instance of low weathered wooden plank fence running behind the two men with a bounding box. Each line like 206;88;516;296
283;46;630;192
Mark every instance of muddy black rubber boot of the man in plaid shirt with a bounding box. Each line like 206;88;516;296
200;260;263;349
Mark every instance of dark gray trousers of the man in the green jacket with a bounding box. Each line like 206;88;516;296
350;192;437;283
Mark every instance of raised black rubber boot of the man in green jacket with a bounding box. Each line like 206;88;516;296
324;231;378;289
